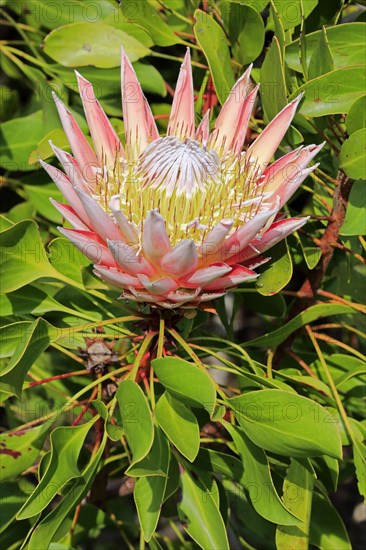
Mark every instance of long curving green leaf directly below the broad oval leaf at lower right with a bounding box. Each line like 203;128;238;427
223;422;299;525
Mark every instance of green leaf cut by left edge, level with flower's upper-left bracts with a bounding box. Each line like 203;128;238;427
0;111;45;172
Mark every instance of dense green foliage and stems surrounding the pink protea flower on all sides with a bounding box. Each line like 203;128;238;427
0;0;366;550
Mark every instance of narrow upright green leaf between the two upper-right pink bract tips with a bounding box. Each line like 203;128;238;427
260;36;287;120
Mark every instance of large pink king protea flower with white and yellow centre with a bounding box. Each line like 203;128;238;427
42;51;321;308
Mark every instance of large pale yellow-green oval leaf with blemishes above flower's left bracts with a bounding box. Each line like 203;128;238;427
44;22;150;68
